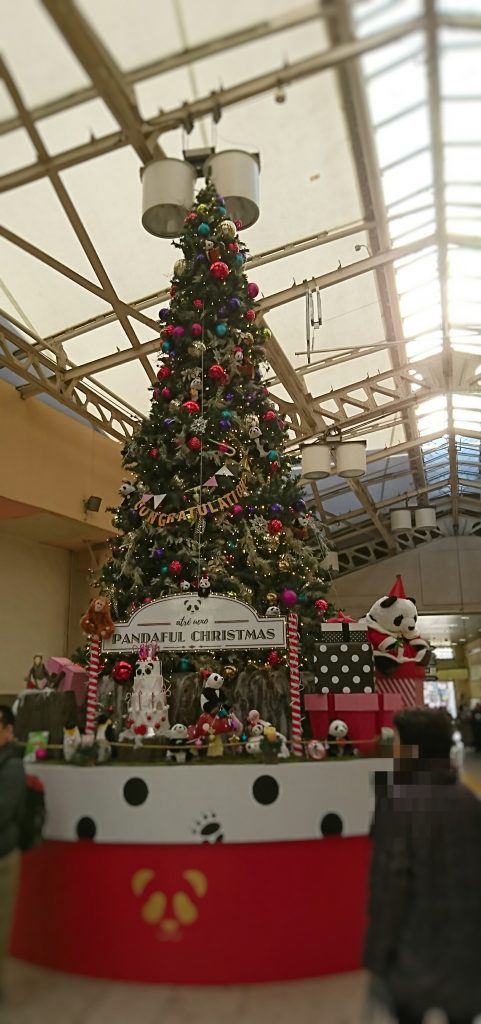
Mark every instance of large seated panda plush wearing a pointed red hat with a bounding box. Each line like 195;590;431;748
365;575;431;676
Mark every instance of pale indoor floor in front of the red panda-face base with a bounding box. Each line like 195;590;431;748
0;752;481;1024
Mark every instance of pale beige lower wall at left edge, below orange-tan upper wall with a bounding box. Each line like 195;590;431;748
0;535;72;693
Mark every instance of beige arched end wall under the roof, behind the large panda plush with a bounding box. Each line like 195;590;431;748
330;537;481;616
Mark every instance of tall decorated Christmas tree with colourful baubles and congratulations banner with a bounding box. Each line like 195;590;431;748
99;182;327;671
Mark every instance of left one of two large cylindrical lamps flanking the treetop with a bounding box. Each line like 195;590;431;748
140;158;195;239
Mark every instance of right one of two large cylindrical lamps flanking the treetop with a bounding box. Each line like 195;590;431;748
204;150;260;227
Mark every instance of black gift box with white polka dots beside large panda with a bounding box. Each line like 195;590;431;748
313;640;375;693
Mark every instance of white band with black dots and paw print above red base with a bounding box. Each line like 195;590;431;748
30;758;392;844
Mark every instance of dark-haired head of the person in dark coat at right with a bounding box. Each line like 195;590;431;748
393;708;453;762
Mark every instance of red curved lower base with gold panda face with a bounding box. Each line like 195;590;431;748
11;837;370;985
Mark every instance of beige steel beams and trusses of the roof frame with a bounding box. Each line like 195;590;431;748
0;0;481;570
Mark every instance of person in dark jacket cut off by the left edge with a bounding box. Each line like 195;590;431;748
0;705;26;994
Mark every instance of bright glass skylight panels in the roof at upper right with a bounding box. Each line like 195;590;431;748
352;0;481;512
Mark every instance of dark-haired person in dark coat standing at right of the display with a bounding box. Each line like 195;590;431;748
363;708;481;1024
